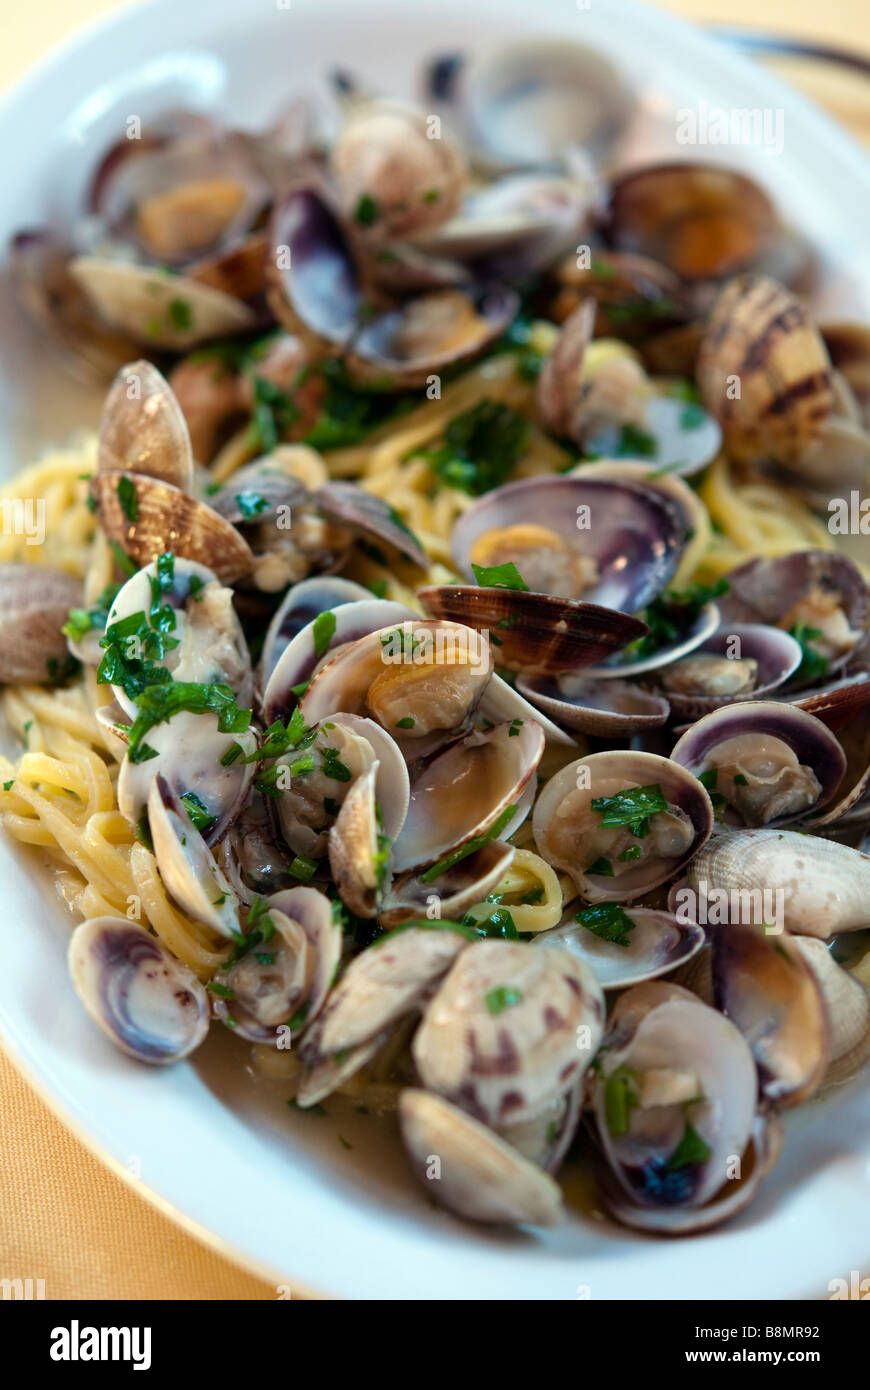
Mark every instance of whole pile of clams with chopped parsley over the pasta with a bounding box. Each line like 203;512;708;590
0;40;870;1234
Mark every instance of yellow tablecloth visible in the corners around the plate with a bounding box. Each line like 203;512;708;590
0;0;870;1298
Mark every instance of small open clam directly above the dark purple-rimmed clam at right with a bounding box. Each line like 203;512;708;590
656;623;803;719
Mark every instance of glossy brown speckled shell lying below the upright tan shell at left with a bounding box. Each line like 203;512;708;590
90;470;254;584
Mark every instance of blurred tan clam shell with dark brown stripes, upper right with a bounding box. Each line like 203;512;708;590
698;275;834;463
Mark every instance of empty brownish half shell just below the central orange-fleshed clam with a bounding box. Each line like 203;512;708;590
393;721;543;872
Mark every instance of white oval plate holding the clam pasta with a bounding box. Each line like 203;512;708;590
0;0;870;1300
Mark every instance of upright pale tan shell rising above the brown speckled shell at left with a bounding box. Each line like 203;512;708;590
97;359;193;492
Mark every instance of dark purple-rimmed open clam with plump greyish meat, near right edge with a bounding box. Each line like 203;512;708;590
671;701;846;826
